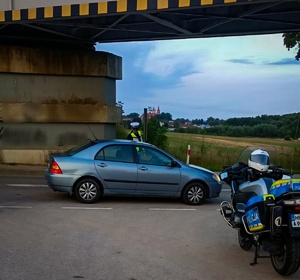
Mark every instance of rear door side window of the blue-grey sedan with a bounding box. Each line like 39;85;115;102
95;145;133;163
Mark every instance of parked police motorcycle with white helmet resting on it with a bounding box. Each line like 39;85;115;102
220;147;300;276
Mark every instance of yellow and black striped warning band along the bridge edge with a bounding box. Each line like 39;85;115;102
0;0;255;23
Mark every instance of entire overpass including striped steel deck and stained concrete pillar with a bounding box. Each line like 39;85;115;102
0;0;300;164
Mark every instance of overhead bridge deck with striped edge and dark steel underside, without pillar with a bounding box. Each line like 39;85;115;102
0;0;300;48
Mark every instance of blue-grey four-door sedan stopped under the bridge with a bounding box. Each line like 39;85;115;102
45;140;222;205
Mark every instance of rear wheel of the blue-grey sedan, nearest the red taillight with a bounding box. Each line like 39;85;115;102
75;179;101;203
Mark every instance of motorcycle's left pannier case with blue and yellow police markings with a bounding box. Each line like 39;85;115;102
245;194;275;232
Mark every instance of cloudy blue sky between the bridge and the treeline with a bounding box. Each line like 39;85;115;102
97;34;300;120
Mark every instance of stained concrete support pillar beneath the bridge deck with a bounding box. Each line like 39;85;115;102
0;45;122;164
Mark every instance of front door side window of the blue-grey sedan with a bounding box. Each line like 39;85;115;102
137;147;171;166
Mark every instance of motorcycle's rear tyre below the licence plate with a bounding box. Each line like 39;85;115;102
271;236;300;276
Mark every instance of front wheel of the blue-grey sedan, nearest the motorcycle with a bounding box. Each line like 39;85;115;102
182;182;206;205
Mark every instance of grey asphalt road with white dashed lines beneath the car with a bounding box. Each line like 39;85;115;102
0;175;300;280
